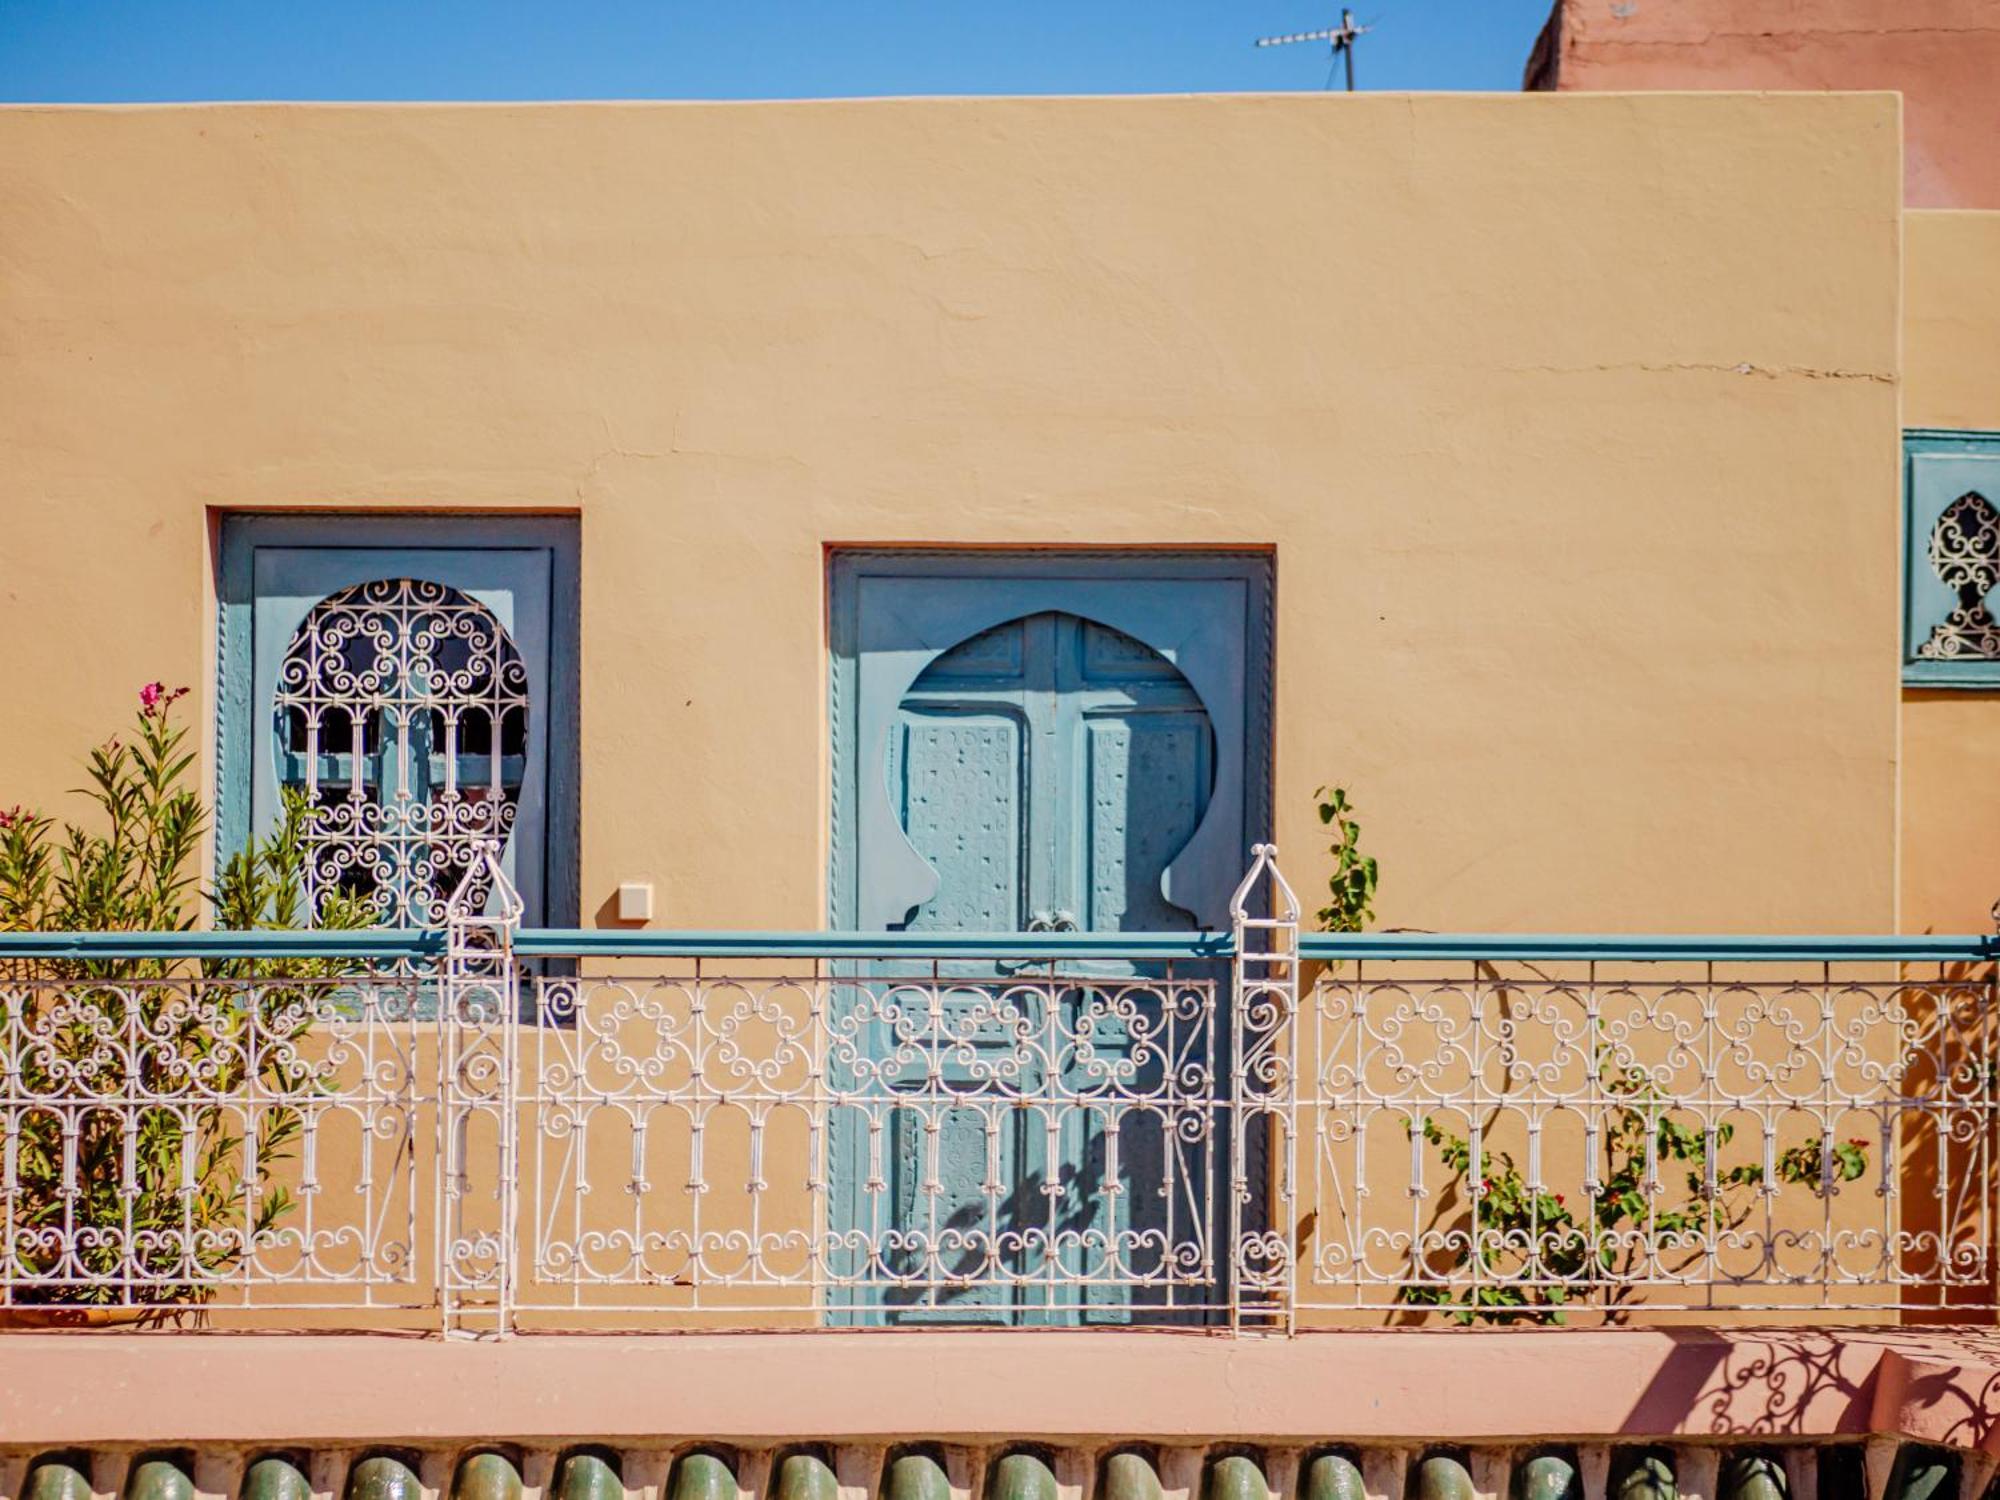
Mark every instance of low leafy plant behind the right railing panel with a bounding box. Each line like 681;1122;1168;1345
1400;1048;1868;1324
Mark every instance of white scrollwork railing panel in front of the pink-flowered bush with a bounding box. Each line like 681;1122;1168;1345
0;960;428;1310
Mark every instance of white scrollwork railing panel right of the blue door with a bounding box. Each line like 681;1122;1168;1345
1294;960;2000;1320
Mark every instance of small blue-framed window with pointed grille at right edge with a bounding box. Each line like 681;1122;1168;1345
1902;428;2000;688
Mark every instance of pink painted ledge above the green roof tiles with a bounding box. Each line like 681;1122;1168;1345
0;1328;2000;1452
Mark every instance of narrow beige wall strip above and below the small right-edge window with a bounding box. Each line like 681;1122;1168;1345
1902;212;2000;932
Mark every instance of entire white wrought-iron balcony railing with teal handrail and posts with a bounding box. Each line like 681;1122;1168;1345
0;850;2000;1332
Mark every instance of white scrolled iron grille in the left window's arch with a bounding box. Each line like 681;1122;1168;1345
274;578;528;928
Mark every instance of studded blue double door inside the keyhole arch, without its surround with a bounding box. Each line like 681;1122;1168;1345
874;610;1214;1322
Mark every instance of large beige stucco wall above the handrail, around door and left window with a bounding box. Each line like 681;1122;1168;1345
0;96;1900;930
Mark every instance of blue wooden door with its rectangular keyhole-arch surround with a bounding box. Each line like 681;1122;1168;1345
834;554;1268;1322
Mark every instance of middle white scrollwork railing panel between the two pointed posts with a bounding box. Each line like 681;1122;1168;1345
522;960;1220;1322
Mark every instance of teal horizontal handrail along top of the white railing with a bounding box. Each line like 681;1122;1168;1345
0;928;2000;964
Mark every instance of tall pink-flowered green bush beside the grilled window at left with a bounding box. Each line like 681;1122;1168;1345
0;682;374;1306
